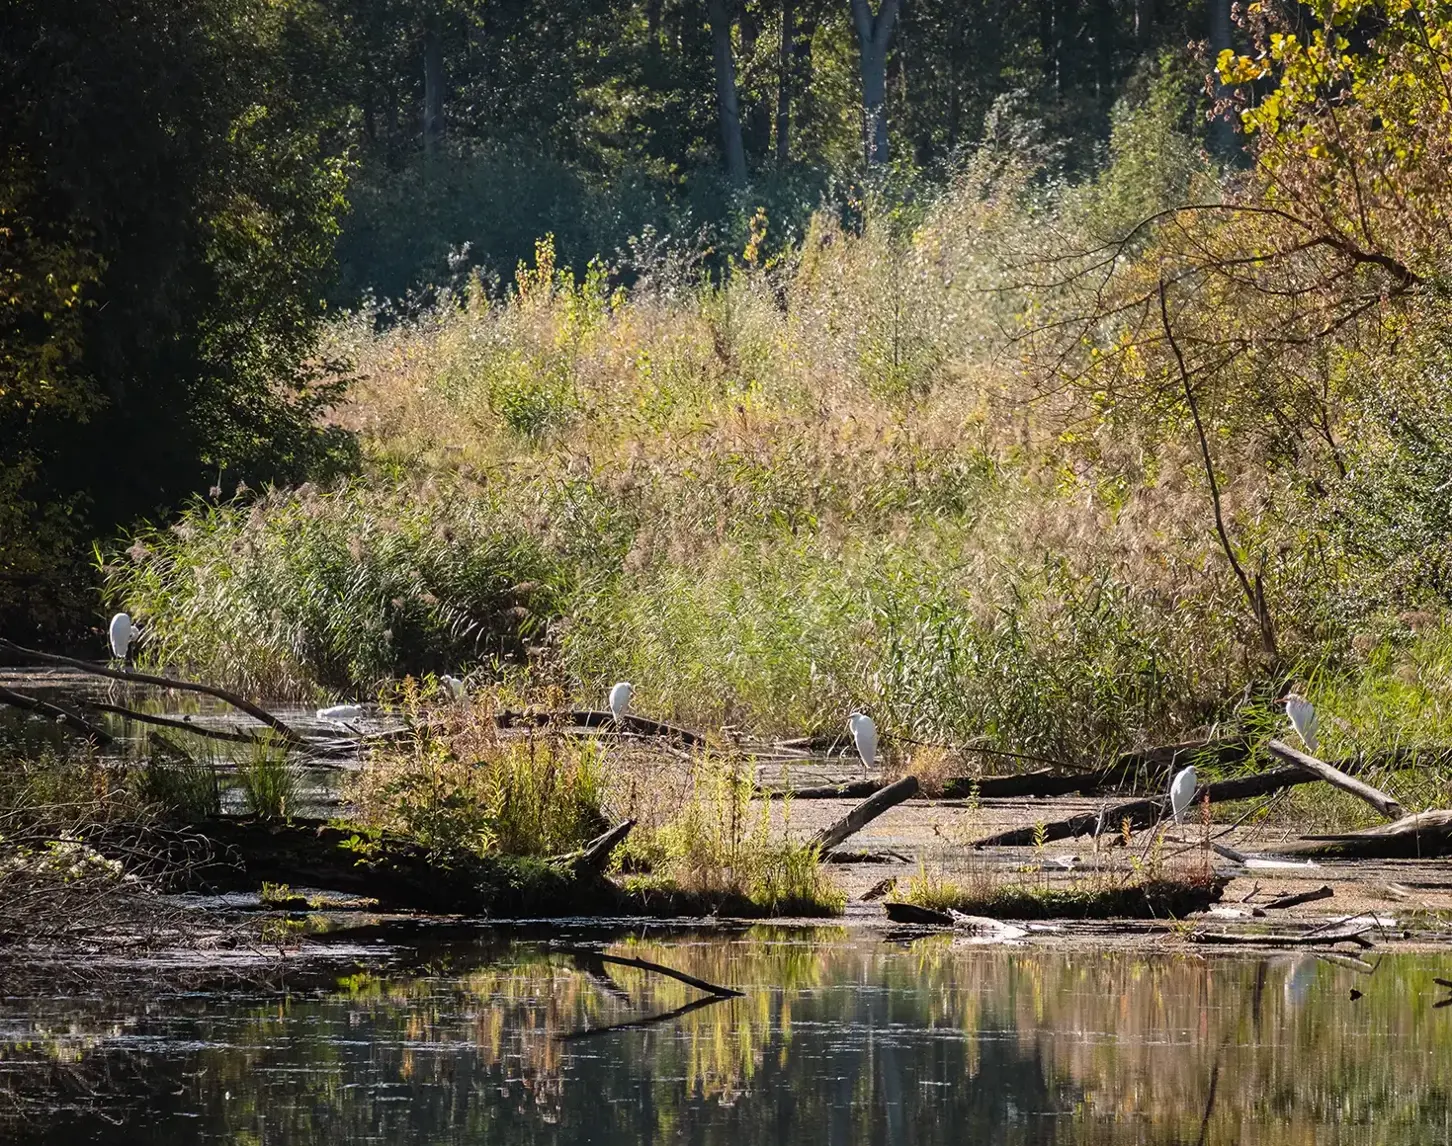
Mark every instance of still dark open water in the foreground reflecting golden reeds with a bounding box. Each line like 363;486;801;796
8;928;1452;1146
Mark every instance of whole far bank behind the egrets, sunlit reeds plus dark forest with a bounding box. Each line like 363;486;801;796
8;0;1452;763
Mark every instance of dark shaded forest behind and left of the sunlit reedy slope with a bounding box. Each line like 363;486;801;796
0;0;1236;633
